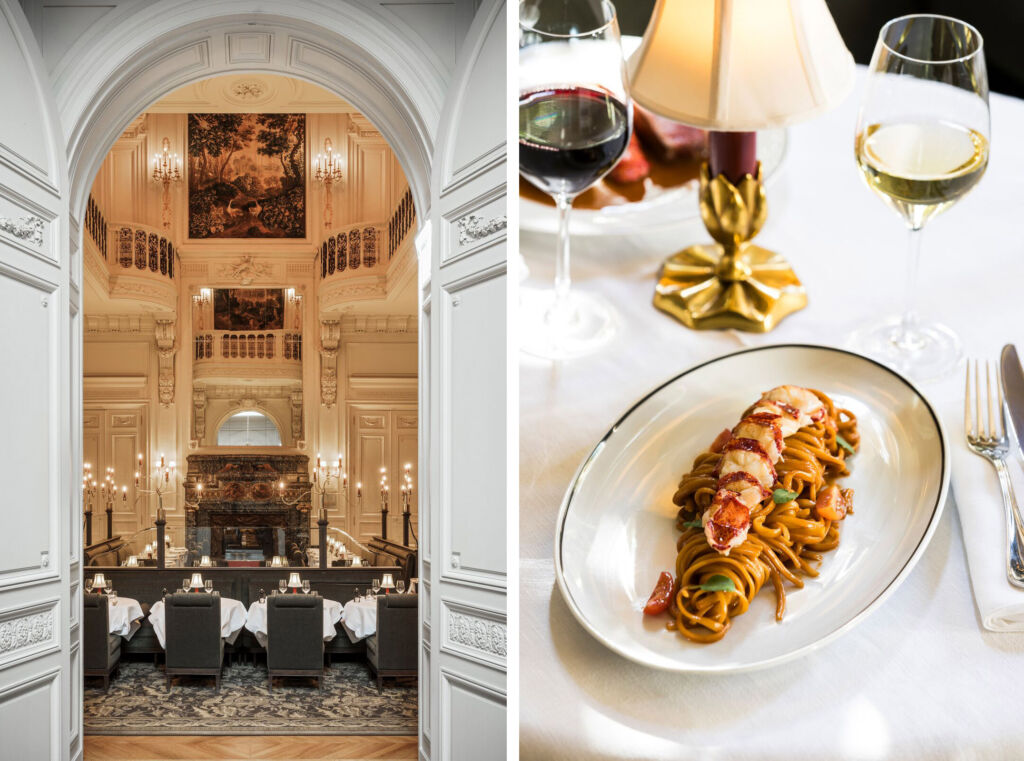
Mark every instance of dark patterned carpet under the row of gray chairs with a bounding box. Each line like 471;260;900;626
84;662;417;734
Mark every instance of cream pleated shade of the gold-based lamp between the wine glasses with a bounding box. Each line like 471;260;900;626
629;0;854;132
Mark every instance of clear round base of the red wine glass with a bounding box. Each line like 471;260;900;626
519;288;615;360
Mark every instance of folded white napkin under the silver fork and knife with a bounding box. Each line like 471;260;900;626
944;397;1024;632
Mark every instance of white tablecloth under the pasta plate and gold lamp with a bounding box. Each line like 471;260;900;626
519;70;1024;761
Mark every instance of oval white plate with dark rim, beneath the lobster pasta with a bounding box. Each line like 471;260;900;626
555;344;949;672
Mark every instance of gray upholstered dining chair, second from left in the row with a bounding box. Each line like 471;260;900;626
164;592;224;691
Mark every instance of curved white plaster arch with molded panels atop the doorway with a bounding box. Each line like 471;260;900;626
53;0;449;224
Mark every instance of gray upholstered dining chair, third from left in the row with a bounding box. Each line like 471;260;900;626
266;594;324;690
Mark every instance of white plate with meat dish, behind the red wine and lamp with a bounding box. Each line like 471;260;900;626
519;36;786;236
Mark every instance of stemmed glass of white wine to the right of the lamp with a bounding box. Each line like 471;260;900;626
850;14;989;381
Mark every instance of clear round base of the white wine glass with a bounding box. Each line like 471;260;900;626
847;318;964;383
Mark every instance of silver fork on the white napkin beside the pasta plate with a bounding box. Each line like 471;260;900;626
964;360;1024;589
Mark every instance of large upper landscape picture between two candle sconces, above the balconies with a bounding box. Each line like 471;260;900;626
188;114;306;239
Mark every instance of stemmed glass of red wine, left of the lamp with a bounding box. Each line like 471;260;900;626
519;0;633;360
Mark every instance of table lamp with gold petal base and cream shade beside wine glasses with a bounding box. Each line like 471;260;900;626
629;0;854;333
